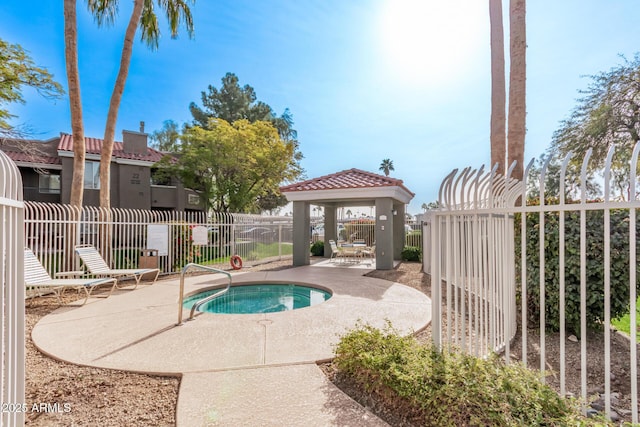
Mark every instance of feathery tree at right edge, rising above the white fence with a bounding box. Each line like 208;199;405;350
550;53;640;197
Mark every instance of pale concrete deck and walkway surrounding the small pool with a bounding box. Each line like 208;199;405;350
32;266;431;427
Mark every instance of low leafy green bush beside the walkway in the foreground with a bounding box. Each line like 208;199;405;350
334;324;602;426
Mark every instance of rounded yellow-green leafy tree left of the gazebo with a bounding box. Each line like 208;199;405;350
161;119;300;213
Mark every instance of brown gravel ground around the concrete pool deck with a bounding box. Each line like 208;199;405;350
26;260;630;427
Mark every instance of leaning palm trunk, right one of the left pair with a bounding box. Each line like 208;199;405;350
100;0;144;209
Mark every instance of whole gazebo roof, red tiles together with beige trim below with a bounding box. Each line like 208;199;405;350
280;169;415;206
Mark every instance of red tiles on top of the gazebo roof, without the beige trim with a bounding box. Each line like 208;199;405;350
280;169;413;194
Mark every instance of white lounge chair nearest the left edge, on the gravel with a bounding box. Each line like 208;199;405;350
24;248;117;305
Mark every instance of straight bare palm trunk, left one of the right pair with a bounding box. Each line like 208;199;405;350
489;0;507;175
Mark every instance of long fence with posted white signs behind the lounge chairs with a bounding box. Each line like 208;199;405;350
25;202;293;274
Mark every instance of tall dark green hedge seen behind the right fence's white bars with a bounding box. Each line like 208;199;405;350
515;210;640;334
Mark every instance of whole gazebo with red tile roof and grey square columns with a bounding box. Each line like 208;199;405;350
280;169;415;270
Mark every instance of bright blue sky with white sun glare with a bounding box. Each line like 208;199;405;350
0;0;640;214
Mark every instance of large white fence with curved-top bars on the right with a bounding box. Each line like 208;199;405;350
425;144;640;423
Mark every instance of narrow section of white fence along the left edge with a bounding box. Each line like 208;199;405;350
0;151;26;426
